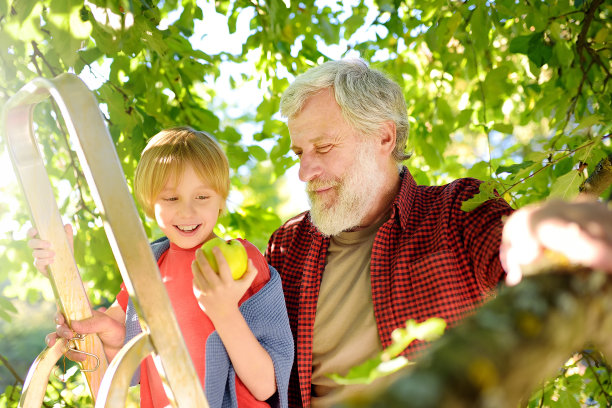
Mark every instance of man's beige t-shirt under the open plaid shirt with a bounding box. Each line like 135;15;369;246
312;216;388;408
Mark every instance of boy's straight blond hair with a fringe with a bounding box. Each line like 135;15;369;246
134;126;230;218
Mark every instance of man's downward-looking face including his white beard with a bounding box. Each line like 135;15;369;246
288;90;384;235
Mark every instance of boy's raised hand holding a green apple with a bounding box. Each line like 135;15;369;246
191;238;257;323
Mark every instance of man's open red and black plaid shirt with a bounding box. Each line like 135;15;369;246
266;169;512;407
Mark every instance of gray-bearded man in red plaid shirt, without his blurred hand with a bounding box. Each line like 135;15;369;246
266;60;609;407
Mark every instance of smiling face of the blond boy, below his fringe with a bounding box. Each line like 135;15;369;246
154;164;224;249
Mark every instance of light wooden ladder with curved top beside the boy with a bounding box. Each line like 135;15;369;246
2;74;208;408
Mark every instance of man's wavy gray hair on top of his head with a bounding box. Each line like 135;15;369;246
280;59;410;163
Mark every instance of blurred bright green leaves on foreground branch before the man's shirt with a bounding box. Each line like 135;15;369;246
328;317;446;385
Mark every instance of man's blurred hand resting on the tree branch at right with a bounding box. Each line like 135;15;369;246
500;200;612;285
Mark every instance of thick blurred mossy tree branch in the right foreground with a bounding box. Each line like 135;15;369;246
343;272;612;408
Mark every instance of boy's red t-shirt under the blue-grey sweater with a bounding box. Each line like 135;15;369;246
117;239;270;408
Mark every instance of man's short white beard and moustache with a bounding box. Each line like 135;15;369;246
307;142;384;236
